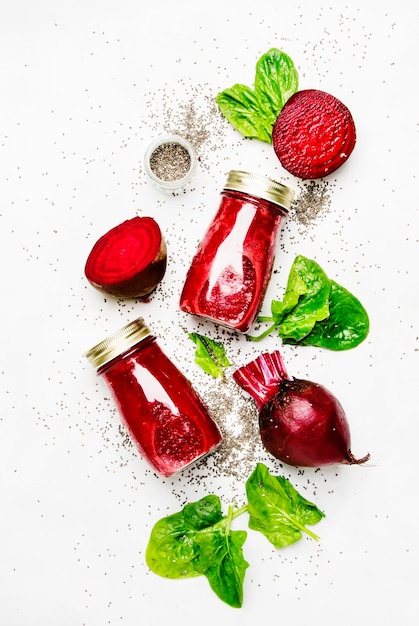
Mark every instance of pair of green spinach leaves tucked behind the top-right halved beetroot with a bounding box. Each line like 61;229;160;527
216;48;298;143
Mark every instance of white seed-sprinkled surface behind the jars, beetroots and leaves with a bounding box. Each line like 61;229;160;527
0;0;419;626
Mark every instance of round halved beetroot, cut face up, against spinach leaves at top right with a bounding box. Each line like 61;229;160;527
272;89;356;179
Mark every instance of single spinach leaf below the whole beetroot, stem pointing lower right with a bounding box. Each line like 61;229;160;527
246;463;324;548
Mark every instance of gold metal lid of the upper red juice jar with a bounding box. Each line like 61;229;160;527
224;170;294;212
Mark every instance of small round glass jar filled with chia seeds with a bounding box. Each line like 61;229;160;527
144;135;197;191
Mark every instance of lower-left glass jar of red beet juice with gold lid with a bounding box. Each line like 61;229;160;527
86;318;222;476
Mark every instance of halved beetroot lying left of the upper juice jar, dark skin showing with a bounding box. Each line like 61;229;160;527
84;217;167;298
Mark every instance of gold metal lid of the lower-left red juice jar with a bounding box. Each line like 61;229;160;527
85;317;151;368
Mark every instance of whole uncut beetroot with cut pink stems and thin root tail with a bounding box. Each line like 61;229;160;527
233;351;369;467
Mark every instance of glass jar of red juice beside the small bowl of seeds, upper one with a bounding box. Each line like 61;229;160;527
180;170;294;333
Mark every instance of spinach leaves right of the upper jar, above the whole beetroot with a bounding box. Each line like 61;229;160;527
248;255;369;350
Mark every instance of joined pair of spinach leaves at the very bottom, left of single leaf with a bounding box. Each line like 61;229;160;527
146;495;249;608
